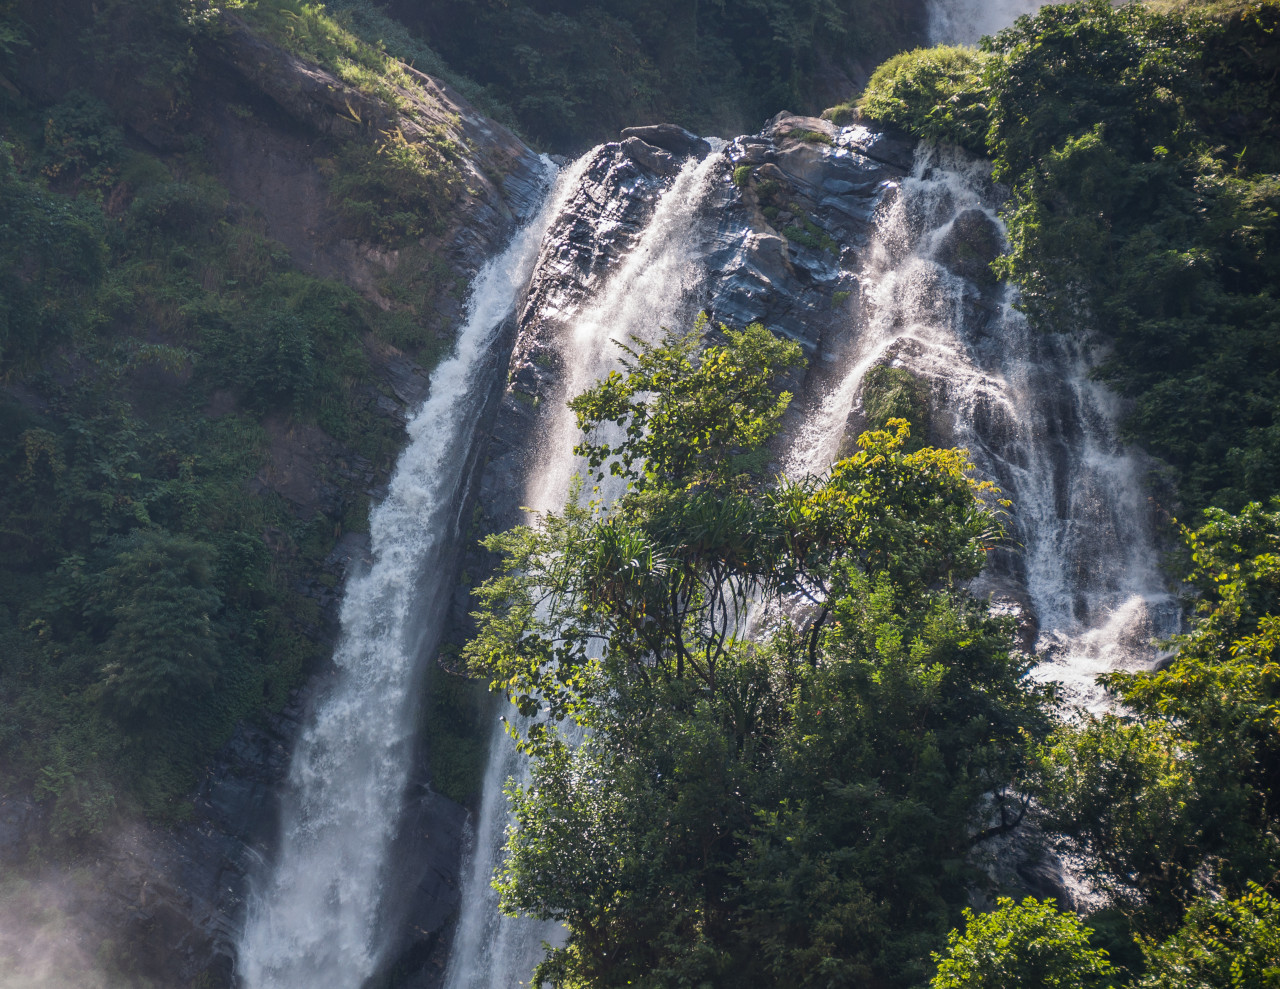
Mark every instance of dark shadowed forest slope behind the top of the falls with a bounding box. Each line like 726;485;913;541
378;0;924;151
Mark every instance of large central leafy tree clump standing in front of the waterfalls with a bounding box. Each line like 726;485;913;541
467;319;1047;986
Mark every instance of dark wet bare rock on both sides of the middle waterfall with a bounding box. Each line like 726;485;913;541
454;114;915;598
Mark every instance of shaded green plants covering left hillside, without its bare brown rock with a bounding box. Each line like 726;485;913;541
0;0;486;823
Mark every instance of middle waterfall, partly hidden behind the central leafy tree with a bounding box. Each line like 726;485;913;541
444;154;722;989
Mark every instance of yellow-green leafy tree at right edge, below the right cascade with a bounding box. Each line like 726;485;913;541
1044;503;1280;928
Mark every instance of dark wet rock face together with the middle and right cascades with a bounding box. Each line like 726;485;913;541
447;115;1178;989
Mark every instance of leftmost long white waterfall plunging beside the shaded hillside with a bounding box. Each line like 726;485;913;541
237;156;558;989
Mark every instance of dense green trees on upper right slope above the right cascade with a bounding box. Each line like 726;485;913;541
836;0;1280;510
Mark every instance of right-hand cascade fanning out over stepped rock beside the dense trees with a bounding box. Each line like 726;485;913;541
787;142;1179;708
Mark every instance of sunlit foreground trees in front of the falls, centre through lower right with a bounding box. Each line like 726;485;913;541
467;326;1280;989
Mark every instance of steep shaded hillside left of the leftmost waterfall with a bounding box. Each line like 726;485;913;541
0;1;543;984
